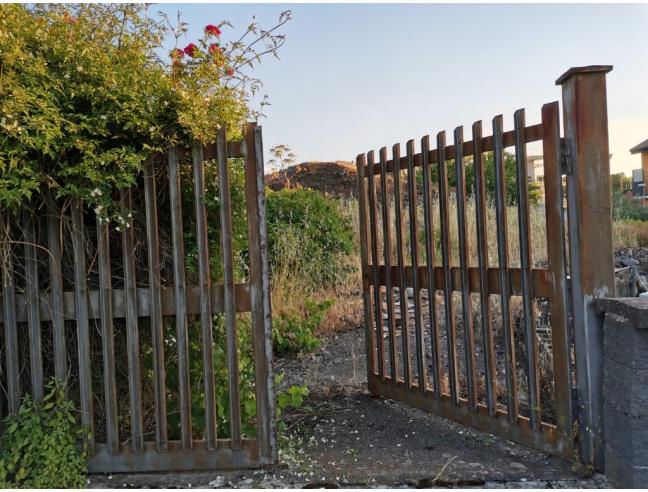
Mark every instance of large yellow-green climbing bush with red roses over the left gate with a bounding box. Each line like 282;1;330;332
0;4;290;220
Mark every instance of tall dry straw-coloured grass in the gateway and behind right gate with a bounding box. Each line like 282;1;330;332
273;190;648;332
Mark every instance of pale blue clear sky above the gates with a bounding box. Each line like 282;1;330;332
157;4;648;174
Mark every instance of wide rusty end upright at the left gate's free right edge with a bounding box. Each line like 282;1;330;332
244;123;278;463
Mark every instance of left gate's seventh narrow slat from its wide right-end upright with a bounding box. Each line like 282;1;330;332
71;198;94;450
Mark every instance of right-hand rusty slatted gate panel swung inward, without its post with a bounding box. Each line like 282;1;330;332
356;102;573;458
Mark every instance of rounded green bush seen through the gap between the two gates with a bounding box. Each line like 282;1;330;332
267;189;354;287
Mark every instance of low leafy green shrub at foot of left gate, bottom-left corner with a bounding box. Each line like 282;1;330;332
0;379;87;489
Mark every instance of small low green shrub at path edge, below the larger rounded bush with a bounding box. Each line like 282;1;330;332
272;299;333;355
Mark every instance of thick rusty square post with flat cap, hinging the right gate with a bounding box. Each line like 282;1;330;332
556;65;614;470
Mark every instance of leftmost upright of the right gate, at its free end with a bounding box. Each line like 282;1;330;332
356;154;376;381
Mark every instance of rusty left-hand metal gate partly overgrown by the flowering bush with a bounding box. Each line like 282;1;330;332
0;124;277;472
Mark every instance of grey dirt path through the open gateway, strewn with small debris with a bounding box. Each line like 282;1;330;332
89;329;607;488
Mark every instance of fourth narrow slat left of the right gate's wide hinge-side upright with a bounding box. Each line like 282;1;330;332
454;126;477;410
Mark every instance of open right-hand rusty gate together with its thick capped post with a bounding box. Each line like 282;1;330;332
357;66;614;462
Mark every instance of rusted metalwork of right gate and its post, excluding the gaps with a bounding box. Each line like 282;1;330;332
357;71;613;463
